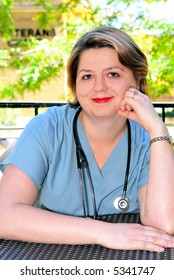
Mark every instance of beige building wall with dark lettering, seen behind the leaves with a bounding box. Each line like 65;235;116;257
0;0;64;101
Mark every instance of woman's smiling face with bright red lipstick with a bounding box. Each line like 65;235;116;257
76;47;137;117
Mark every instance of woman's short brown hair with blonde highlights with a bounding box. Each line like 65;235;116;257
67;26;148;107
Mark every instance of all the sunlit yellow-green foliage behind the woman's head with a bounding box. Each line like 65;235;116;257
0;0;174;99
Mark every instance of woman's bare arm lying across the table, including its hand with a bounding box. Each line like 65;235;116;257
0;165;174;252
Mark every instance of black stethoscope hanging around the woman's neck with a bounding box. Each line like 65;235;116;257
73;107;131;219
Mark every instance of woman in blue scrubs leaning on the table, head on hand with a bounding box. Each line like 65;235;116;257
0;27;174;252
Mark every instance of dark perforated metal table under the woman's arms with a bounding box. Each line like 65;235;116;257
0;214;174;260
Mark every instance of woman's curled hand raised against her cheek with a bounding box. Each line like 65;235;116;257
118;87;167;136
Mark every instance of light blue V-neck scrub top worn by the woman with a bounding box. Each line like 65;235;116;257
0;105;149;216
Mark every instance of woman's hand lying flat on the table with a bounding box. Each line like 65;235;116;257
99;223;174;252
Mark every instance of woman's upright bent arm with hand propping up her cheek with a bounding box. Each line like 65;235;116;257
119;88;174;234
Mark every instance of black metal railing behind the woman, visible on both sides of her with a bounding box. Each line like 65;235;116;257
0;101;174;122
